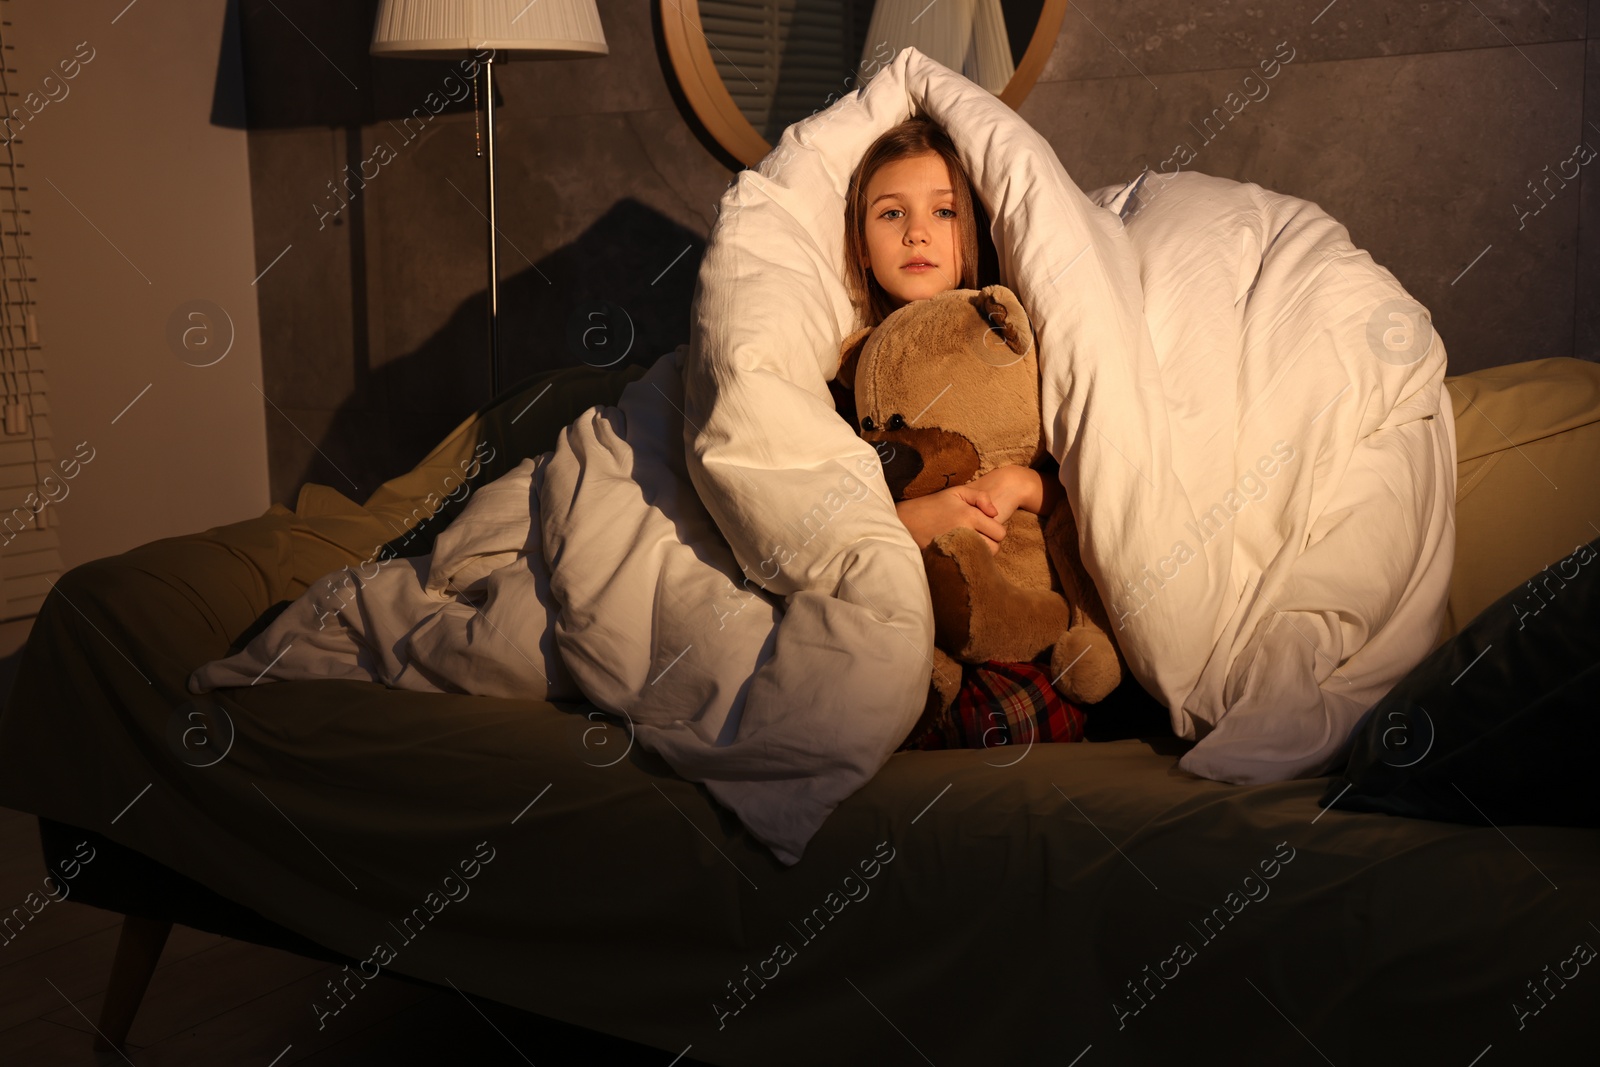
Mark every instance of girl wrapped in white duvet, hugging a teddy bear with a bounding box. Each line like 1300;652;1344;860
834;117;1064;552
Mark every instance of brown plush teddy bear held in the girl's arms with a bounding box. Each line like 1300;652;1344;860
834;285;1123;710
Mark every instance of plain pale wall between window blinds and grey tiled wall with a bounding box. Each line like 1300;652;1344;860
14;0;265;568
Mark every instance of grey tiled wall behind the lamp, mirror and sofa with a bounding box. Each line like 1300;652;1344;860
242;0;1600;502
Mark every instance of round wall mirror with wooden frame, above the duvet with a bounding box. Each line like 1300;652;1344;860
661;0;1067;166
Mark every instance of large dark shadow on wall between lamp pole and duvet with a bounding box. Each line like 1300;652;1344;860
300;198;706;511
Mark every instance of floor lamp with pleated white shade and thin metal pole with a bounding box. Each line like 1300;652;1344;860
371;0;610;395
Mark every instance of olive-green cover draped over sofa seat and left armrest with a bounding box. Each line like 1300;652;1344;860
0;370;1600;1067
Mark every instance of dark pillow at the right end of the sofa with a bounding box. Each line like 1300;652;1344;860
1323;537;1600;825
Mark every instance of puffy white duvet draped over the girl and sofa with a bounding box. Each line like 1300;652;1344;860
190;48;1454;864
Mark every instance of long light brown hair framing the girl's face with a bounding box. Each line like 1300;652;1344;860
845;115;979;326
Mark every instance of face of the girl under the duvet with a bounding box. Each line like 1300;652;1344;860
864;152;962;307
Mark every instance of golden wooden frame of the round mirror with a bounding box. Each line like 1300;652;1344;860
661;0;1067;166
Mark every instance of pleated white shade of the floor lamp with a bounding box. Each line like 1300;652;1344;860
371;0;610;61
